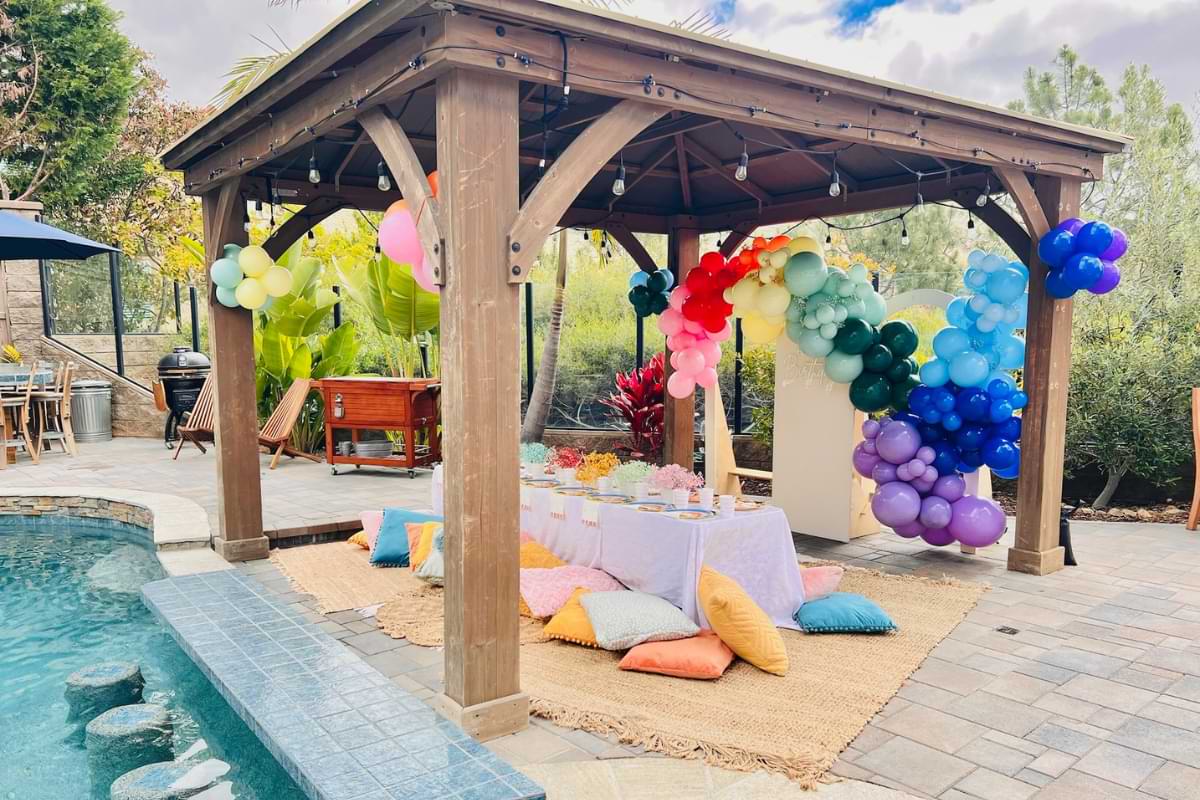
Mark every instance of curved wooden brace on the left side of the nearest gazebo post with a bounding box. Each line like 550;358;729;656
359;107;445;284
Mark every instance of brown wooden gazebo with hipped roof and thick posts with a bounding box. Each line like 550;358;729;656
163;0;1128;738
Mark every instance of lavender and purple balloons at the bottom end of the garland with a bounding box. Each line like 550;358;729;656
853;417;1007;547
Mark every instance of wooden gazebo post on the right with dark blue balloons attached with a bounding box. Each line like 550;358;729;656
1008;175;1080;575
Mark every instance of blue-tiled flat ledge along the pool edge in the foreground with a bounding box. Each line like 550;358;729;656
142;570;545;800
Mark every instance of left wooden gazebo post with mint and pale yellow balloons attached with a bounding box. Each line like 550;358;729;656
202;179;269;561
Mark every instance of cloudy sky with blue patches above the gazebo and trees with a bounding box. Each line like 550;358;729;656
109;0;1200;114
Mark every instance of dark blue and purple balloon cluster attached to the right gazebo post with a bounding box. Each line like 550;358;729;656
1038;217;1129;300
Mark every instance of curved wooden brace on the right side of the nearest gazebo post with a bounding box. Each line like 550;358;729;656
506;100;666;283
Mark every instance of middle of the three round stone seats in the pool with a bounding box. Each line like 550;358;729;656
85;703;174;796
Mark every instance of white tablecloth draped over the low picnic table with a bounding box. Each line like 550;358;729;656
432;468;804;628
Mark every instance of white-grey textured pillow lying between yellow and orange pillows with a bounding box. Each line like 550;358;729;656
580;591;700;650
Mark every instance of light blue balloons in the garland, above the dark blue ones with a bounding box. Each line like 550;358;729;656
920;249;1030;389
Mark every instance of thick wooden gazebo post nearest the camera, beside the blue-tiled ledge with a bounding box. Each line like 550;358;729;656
437;70;529;739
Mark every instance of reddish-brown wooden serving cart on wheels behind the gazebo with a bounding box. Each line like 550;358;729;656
313;378;442;477
